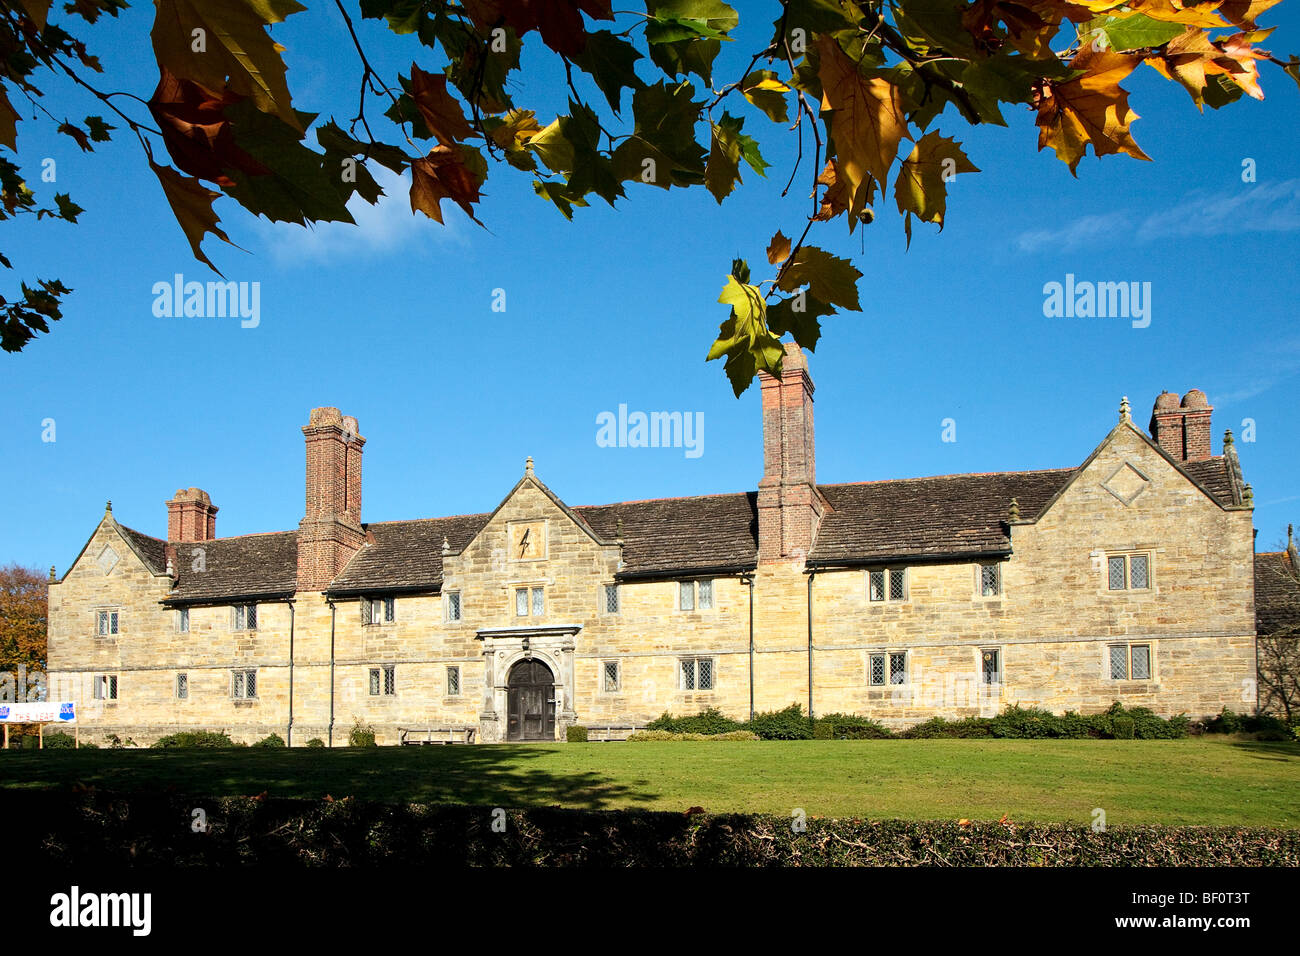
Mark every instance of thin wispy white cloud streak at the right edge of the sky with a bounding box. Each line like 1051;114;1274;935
1015;179;1300;252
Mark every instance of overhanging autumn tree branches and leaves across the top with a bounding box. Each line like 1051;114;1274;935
0;0;1300;394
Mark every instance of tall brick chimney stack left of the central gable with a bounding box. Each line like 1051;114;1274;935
298;407;365;591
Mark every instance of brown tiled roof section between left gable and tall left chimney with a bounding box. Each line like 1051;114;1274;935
168;531;298;604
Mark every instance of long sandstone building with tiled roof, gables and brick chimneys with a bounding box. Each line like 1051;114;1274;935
49;346;1274;745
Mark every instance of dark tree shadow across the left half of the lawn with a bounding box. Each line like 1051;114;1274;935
0;745;657;810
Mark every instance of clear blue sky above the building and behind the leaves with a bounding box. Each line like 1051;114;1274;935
0;3;1300;572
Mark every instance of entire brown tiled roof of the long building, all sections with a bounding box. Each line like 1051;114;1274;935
139;458;1232;602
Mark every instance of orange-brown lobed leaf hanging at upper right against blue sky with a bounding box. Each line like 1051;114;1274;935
1036;46;1151;173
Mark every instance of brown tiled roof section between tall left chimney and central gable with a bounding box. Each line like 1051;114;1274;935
329;515;489;593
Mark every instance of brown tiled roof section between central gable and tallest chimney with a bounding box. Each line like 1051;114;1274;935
573;492;758;576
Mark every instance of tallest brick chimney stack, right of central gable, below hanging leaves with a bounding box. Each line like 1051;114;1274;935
758;342;827;562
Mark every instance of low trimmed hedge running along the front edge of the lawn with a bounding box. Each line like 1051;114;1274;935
12;791;1300;869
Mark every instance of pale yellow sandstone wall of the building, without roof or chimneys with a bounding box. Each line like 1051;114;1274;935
49;428;1255;745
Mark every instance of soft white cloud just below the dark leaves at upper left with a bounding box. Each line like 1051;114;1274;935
245;165;467;265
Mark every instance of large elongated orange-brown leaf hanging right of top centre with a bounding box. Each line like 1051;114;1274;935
818;35;911;216
